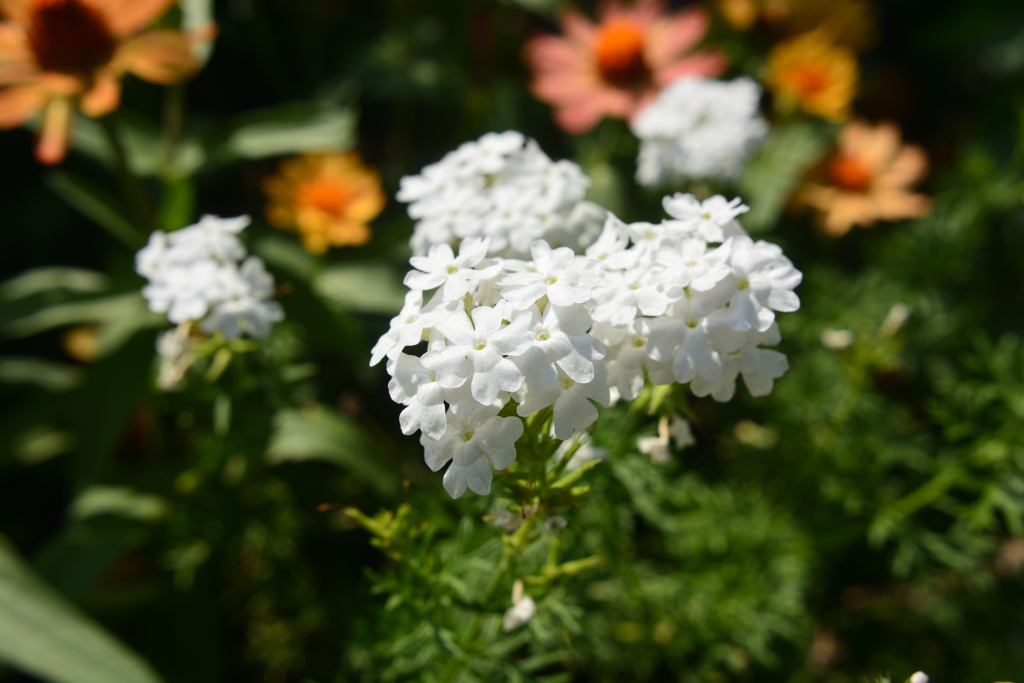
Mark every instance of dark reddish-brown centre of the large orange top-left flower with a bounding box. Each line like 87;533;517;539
29;0;117;74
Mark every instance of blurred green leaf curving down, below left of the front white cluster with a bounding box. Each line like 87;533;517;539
266;405;398;496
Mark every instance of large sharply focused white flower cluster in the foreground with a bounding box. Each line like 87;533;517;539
371;189;801;498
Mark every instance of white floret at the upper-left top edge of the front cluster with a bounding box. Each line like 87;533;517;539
406;238;502;301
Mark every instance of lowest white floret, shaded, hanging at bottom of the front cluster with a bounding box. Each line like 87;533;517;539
420;409;523;498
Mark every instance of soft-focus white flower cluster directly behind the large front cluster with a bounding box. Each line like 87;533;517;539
398;130;604;258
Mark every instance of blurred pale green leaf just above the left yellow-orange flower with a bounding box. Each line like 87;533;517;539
216;102;355;161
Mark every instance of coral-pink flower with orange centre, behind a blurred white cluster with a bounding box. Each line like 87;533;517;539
525;0;727;134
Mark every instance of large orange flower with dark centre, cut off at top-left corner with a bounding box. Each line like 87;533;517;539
0;0;212;164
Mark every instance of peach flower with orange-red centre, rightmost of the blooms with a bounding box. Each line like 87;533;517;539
798;121;932;238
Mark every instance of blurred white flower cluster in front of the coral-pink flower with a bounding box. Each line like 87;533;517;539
633;78;768;186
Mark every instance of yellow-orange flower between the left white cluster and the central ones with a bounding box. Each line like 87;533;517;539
263;152;385;254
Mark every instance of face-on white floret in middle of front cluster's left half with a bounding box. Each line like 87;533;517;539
423;306;534;405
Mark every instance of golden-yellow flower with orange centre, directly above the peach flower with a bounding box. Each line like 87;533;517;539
766;30;858;121
